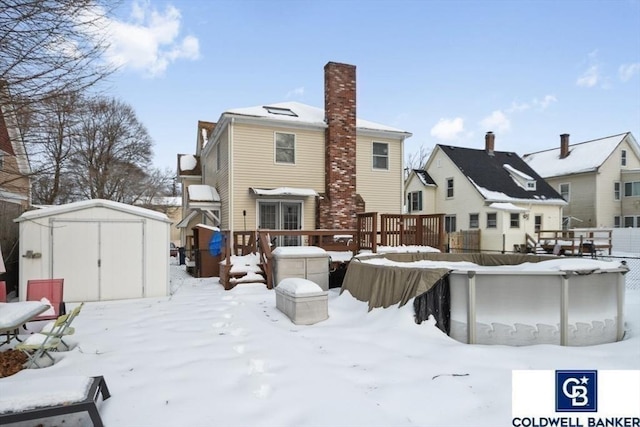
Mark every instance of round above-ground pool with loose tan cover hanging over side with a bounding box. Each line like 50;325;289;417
342;252;628;346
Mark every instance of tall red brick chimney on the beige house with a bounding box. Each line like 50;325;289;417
317;62;364;229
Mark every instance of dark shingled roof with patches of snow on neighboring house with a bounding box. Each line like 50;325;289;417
437;144;566;205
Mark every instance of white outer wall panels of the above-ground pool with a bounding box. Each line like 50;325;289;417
449;268;627;346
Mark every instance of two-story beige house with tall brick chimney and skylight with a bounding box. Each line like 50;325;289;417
178;62;411;244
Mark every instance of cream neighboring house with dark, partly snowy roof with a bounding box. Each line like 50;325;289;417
420;132;566;251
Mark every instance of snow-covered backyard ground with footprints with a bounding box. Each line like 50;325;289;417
0;259;640;426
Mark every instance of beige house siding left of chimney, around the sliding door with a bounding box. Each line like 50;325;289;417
226;123;324;230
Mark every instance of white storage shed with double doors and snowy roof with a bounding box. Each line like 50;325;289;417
15;199;171;302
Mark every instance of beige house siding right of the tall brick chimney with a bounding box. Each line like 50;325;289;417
356;136;404;214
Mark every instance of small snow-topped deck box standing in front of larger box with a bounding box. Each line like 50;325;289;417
276;278;329;325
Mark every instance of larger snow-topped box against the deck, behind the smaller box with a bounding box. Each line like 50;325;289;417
273;246;329;291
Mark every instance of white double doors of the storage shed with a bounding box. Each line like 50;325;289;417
52;220;144;302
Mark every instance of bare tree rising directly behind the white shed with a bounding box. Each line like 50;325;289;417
70;98;158;203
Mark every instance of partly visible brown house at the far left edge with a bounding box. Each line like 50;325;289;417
0;81;31;290
